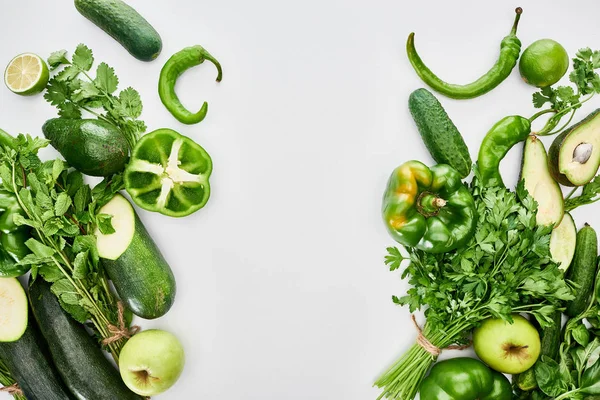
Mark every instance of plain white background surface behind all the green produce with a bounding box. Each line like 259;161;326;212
0;0;600;400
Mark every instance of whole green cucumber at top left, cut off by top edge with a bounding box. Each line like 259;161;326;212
75;0;162;61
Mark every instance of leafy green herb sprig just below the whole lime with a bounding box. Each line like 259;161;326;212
530;47;600;136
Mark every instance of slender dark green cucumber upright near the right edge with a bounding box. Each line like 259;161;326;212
565;225;598;317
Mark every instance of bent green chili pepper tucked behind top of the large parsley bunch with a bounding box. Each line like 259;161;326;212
477;115;531;186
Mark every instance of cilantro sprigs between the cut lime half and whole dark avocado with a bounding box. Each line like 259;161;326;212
44;44;146;148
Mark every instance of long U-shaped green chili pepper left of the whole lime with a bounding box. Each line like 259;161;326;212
406;7;523;99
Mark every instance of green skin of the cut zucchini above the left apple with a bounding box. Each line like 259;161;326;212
101;206;177;319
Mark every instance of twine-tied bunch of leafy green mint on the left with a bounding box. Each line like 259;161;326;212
0;135;129;360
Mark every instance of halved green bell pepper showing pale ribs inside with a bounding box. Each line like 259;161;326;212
124;129;212;217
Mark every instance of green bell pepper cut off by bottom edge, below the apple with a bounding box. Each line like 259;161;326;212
420;358;512;400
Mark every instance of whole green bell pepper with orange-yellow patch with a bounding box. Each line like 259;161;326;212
383;161;477;253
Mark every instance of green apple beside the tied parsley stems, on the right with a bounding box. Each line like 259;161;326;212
473;315;541;374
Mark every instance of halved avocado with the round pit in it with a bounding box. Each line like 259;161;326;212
548;109;600;186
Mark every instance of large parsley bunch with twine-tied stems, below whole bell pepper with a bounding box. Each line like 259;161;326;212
375;171;573;400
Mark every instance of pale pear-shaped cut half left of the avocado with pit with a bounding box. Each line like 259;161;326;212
521;135;564;226
